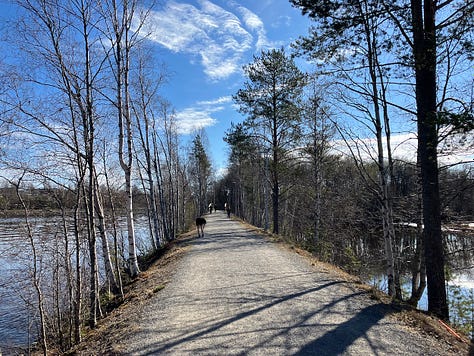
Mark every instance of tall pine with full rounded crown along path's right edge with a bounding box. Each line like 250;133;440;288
234;49;306;233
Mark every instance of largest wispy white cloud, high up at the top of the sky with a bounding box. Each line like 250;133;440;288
143;0;268;80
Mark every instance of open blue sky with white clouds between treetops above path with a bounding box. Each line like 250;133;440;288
139;0;309;174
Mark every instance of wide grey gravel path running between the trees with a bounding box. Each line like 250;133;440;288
119;212;460;355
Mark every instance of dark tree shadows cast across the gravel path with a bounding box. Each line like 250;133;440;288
130;216;391;355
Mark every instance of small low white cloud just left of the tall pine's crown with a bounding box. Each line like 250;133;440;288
176;96;232;134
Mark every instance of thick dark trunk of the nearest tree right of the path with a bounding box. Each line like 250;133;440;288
411;0;449;320
